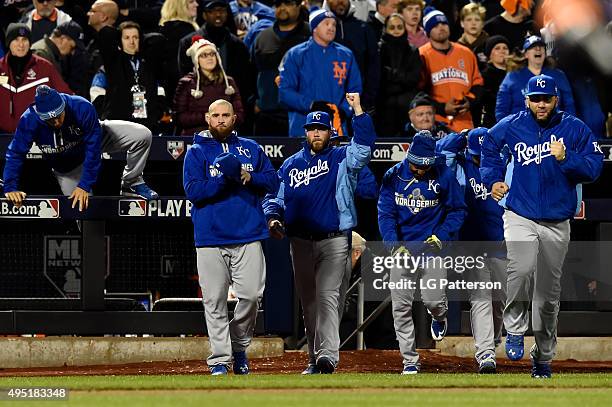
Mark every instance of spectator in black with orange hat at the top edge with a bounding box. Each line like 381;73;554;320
484;0;535;52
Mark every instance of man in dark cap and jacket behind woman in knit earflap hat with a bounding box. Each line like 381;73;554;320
178;0;257;123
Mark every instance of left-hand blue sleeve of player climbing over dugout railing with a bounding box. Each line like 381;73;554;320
2;118;34;192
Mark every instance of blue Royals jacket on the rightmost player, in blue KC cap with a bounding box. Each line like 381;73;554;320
480;109;603;221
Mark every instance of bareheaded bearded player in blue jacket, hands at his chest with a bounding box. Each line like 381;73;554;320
183;99;278;375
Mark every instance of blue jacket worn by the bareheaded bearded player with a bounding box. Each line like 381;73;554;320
183;131;278;247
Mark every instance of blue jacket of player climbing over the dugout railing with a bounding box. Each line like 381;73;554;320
4;93;102;192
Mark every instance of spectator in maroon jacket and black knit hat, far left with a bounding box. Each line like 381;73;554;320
0;23;72;133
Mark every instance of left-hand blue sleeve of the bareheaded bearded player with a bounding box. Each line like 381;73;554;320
183;147;227;205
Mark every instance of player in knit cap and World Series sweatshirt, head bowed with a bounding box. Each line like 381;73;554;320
378;130;465;374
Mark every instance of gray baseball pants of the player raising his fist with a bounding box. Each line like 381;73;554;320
290;235;351;366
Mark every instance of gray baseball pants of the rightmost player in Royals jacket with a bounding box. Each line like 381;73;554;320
504;210;570;363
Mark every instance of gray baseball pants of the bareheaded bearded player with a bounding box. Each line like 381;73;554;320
196;241;266;367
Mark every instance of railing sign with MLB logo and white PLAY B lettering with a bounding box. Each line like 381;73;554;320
118;199;193;218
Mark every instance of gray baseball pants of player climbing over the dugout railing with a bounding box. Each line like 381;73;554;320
53;120;152;195
